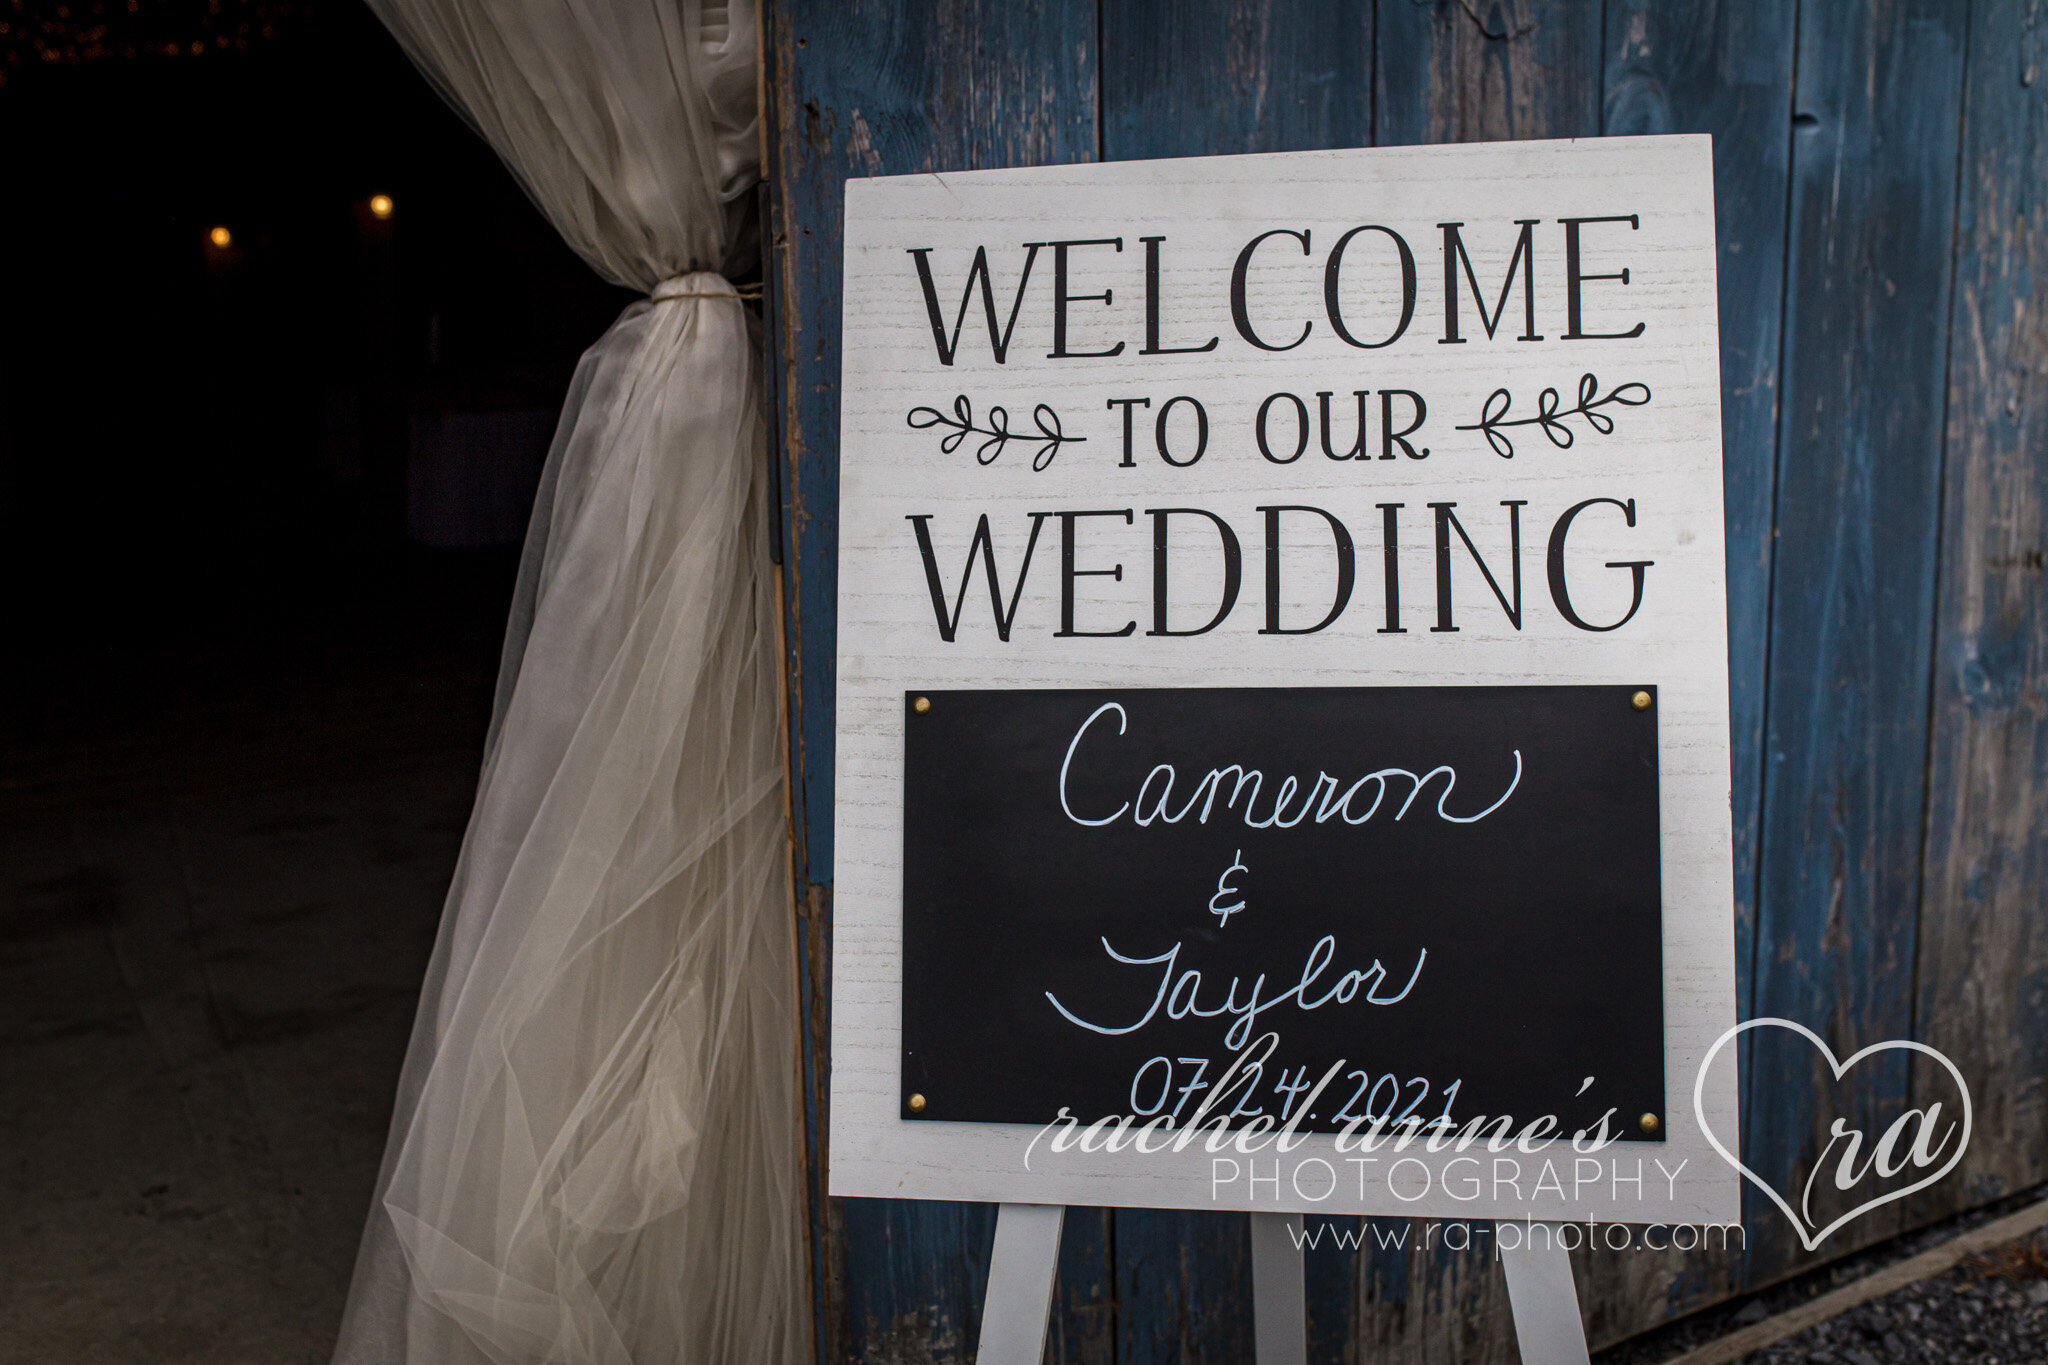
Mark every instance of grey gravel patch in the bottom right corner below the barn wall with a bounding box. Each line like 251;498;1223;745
1747;1234;2048;1365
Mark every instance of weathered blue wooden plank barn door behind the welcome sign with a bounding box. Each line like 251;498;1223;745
766;0;2048;1365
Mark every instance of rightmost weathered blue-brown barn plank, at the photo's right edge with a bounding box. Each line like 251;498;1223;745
1913;0;2048;1218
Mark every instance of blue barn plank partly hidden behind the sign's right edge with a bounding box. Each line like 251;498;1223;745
1585;0;1798;1342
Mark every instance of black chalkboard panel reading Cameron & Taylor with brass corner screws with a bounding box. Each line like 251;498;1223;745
901;686;1665;1140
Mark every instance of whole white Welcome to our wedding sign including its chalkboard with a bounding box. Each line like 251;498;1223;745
831;137;1735;1222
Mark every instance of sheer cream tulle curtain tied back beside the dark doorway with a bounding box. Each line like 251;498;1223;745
334;0;809;1365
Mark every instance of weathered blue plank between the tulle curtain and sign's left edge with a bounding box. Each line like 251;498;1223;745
768;0;1108;1361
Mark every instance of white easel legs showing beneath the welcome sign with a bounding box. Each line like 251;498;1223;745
975;1203;1587;1365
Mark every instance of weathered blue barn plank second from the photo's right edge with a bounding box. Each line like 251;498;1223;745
1745;0;1966;1281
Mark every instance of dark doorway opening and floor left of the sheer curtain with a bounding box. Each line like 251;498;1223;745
0;0;631;1365
